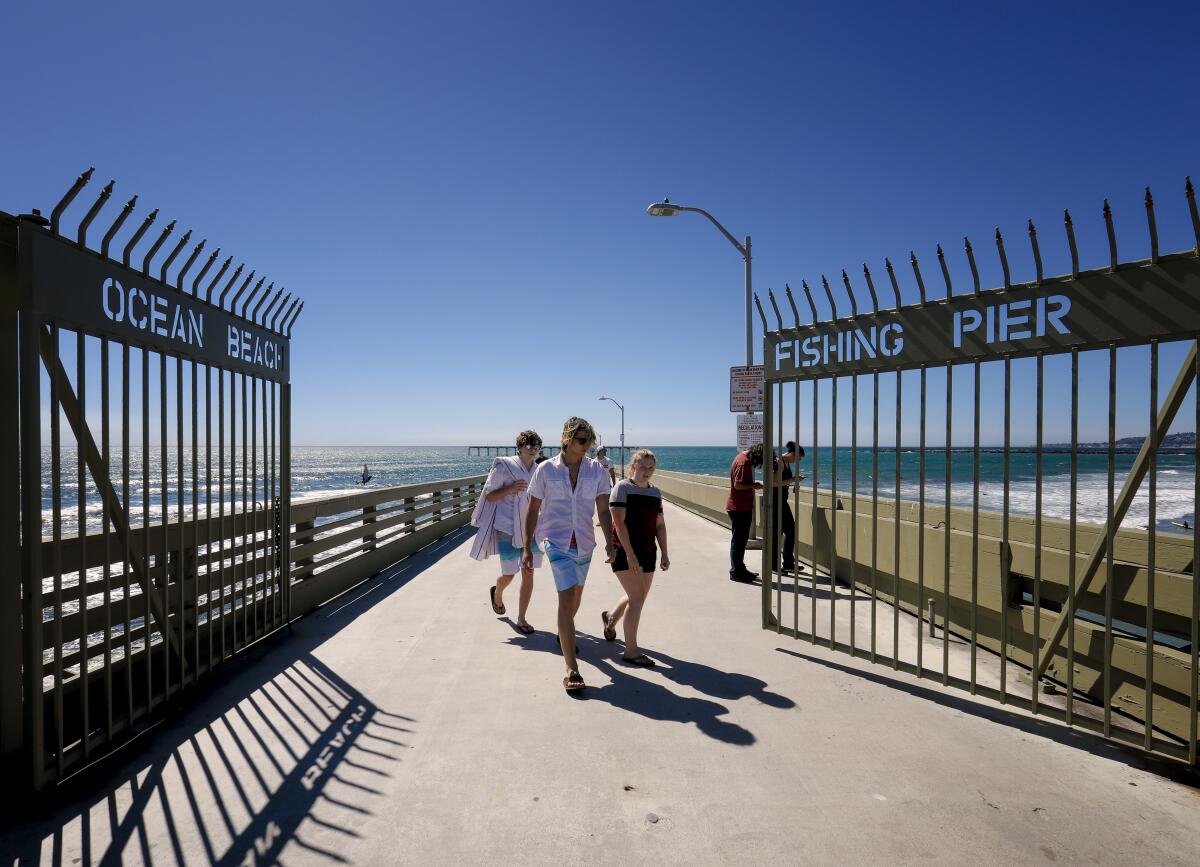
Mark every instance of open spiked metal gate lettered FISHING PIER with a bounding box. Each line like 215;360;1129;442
758;179;1200;765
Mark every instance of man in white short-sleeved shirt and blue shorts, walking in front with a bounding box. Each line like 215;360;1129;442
521;415;616;693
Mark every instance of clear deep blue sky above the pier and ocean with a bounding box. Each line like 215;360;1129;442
9;2;1200;444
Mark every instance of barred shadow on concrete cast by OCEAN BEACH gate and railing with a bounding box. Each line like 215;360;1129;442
0;528;470;866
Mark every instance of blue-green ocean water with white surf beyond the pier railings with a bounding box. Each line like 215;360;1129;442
32;446;1195;538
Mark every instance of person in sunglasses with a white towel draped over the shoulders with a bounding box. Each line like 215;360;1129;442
470;430;541;635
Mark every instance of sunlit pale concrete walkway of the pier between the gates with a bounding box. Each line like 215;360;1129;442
0;506;1200;865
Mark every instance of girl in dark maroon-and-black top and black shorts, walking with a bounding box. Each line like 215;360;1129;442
600;449;671;666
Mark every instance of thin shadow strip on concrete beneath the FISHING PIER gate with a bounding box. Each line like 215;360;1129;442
775;647;1200;789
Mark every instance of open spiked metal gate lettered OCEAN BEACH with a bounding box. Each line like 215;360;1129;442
0;169;304;789
